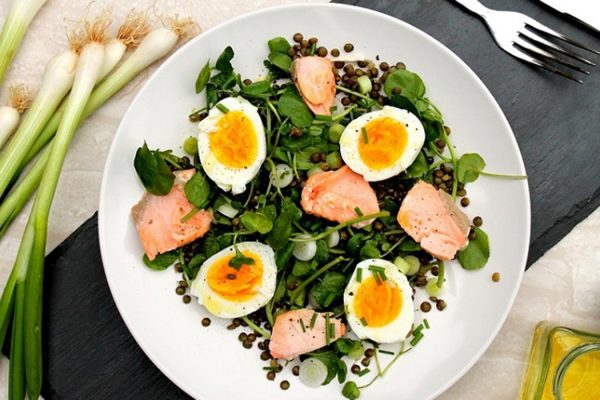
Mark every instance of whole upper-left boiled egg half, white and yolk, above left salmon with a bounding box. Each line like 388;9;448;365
198;97;267;194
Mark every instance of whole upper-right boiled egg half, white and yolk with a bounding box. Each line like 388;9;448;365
340;106;425;182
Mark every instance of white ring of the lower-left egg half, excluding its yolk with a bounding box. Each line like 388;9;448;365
190;242;277;318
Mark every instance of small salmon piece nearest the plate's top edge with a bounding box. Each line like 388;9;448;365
290;56;335;115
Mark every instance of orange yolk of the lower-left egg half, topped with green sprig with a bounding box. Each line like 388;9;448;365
206;251;263;302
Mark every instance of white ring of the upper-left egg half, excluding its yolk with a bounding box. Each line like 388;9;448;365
198;97;267;194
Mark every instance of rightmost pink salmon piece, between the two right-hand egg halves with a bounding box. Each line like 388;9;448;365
398;181;469;260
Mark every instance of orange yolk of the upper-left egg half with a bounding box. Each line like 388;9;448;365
208;111;258;168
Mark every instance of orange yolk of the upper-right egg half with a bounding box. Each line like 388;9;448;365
358;117;408;170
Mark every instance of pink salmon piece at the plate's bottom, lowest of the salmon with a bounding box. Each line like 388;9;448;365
269;308;346;360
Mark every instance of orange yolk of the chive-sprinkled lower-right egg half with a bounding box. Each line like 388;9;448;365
354;276;402;327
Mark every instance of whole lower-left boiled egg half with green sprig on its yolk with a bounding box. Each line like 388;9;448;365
191;242;277;318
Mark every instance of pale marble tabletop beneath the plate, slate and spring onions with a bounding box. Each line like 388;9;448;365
0;0;600;400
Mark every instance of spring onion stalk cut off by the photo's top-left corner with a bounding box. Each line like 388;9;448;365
0;0;47;83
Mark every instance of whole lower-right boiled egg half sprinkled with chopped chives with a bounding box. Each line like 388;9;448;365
344;259;414;343
